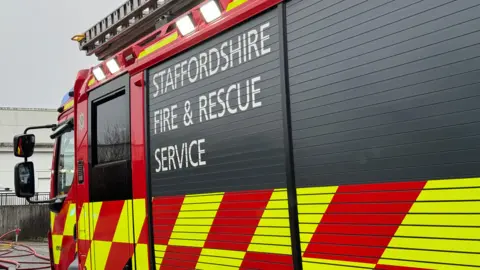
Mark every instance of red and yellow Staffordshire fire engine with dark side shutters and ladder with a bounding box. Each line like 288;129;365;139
10;0;480;270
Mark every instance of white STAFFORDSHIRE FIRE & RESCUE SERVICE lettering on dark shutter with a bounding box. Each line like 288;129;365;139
150;22;272;173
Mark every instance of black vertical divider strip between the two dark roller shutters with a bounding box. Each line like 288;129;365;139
278;2;302;270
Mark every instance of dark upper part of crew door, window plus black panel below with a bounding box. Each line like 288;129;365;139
89;83;133;202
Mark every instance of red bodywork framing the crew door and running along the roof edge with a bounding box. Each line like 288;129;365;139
69;0;281;267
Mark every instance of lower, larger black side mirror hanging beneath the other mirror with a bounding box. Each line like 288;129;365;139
15;161;35;198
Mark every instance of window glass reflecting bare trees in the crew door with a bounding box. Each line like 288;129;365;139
94;91;130;165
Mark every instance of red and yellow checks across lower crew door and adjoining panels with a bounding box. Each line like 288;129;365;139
78;199;148;269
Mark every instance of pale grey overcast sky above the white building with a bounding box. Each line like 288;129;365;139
0;0;125;109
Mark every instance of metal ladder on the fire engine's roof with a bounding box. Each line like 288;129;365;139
72;0;201;60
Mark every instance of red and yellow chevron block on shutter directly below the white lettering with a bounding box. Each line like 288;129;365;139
153;189;293;269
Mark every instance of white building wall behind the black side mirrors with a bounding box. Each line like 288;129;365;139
0;107;58;192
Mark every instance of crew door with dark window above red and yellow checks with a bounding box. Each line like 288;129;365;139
86;74;134;270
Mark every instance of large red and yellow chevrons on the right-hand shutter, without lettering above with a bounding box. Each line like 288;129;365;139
297;178;480;269
